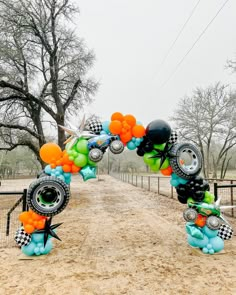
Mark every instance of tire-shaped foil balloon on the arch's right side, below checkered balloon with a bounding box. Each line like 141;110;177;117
169;143;202;179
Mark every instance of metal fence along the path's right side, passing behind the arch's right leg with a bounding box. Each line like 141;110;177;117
111;173;236;217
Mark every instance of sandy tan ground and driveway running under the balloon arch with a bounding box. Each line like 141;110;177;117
0;176;236;295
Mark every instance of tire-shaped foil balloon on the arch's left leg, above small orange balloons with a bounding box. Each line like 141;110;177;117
26;176;70;216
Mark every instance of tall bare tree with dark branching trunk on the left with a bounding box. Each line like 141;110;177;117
0;0;98;166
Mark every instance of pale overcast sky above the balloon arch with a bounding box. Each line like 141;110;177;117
76;0;236;126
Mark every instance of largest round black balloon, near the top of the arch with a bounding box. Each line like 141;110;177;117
146;120;171;144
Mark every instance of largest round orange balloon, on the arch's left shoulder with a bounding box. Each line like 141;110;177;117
39;142;62;164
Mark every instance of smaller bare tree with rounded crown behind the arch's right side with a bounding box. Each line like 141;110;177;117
171;83;236;178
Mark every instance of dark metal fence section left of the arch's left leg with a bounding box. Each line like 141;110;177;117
0;189;27;248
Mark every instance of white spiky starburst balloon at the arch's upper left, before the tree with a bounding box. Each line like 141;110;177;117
58;116;97;149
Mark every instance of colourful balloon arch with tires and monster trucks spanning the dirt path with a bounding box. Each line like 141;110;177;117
15;112;233;256
